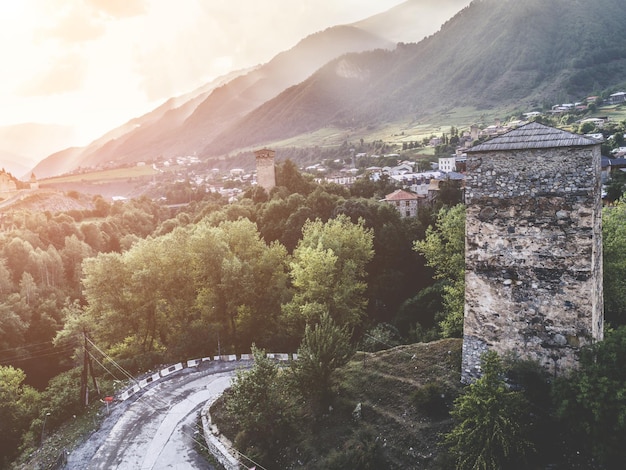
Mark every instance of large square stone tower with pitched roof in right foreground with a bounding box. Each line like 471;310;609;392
461;123;604;382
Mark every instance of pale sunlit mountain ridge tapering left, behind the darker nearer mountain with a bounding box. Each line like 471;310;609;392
35;26;393;176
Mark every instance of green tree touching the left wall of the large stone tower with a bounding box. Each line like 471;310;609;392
414;204;465;337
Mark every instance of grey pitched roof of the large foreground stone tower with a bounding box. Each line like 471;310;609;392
468;122;599;152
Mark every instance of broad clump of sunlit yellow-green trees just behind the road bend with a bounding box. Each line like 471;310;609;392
72;219;288;360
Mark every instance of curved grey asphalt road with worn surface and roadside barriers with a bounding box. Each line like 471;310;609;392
65;362;248;470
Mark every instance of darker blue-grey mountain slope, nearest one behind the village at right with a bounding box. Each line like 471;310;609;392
204;0;626;156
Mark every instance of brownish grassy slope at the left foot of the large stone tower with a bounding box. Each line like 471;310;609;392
212;339;462;470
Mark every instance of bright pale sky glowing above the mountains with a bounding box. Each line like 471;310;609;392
0;0;403;145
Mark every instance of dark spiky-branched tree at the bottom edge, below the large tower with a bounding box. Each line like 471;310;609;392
444;351;533;470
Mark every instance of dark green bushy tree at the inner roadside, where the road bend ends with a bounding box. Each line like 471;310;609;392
292;313;353;408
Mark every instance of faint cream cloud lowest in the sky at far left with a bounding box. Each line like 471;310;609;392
18;53;87;97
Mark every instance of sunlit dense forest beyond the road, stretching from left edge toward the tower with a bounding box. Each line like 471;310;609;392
0;161;441;462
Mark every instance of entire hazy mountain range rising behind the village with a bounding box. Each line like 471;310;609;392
14;0;626;177
